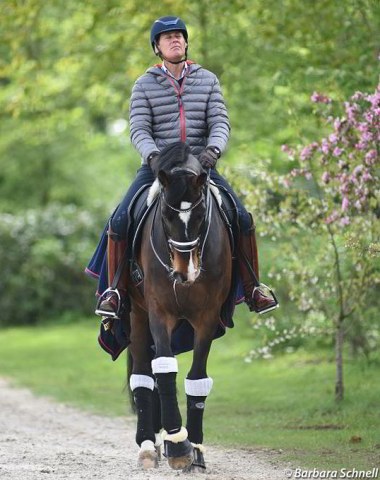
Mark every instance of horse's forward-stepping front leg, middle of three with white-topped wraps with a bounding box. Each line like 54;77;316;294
150;315;193;470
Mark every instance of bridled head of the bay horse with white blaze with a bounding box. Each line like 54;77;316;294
157;143;207;284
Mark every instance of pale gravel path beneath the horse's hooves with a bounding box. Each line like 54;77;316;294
0;379;285;480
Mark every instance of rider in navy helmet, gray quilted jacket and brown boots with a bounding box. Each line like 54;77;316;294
96;16;277;317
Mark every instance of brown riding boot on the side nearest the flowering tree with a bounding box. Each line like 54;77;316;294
238;216;278;313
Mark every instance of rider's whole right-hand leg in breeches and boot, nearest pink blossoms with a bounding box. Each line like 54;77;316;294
210;170;278;313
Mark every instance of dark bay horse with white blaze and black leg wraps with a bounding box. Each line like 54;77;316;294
128;143;232;470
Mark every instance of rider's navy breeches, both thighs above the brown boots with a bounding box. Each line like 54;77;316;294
111;165;252;238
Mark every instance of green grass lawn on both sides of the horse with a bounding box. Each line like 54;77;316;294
0;318;380;469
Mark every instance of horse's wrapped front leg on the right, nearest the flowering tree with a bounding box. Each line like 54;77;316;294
185;316;219;472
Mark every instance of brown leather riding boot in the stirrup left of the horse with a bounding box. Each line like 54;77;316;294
95;226;128;318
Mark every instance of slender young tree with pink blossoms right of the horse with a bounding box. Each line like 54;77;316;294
236;81;380;400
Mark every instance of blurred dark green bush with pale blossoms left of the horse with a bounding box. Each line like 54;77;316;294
0;204;105;326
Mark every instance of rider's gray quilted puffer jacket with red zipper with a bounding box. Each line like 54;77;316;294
129;62;230;163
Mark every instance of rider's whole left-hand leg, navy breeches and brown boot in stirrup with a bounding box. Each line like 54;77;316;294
95;165;154;317
